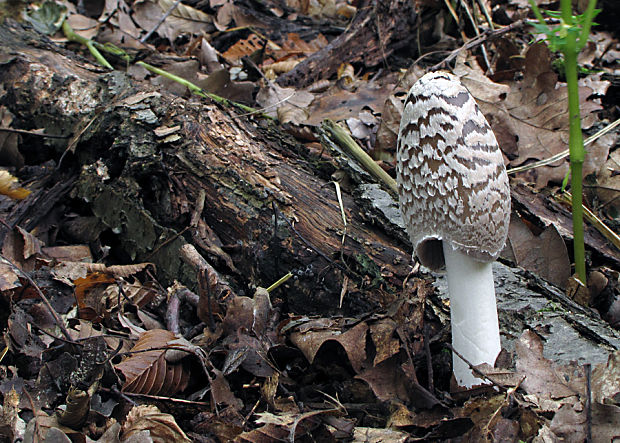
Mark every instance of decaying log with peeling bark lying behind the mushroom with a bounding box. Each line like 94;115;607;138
0;23;620;368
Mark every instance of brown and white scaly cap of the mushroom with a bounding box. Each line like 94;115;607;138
396;71;510;270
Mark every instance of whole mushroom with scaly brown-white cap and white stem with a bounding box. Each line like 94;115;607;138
396;71;510;388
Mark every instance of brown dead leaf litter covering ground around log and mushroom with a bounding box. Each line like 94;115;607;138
0;0;620;442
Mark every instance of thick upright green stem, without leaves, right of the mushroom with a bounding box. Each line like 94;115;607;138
560;0;586;284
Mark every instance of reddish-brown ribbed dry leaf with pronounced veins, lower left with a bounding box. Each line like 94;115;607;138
115;329;189;395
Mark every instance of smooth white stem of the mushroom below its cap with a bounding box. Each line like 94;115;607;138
443;241;501;388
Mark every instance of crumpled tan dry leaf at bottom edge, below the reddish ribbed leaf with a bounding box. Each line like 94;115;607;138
121;405;191;443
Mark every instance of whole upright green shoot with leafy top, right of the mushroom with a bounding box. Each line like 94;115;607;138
530;0;599;285
